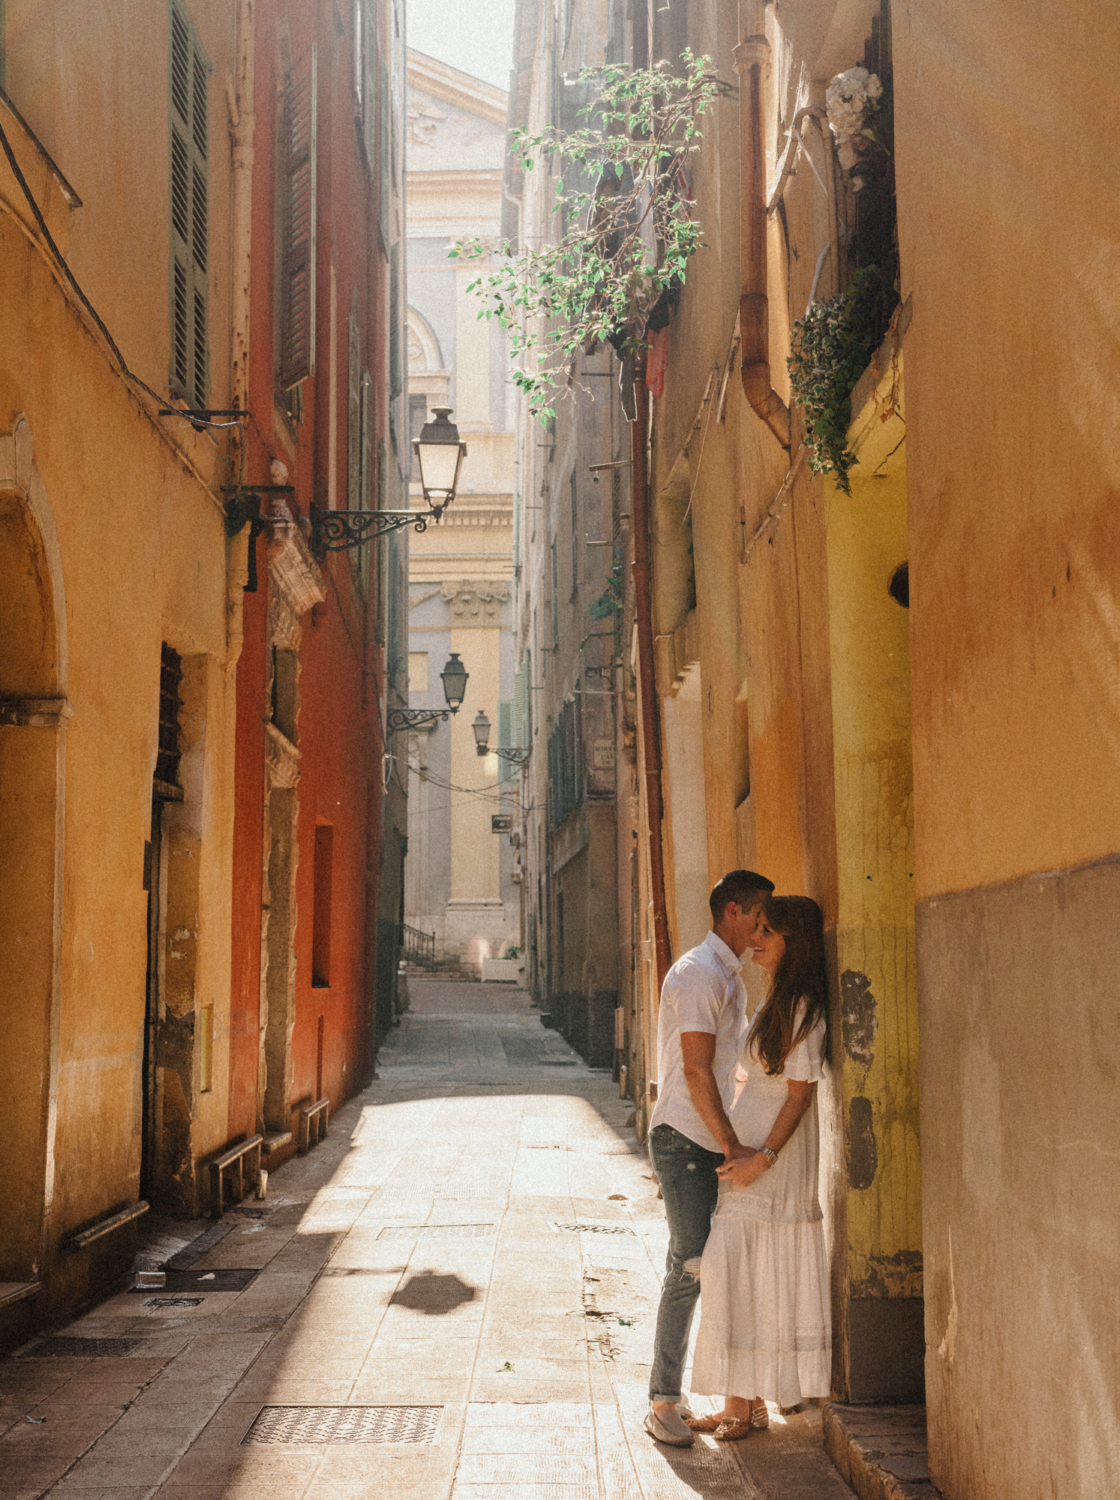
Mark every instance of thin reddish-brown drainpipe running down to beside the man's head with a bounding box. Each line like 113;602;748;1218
630;356;672;995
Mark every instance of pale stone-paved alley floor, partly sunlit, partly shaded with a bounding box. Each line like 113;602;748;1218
0;981;852;1500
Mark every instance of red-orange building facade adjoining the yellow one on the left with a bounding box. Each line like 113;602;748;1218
229;0;406;1164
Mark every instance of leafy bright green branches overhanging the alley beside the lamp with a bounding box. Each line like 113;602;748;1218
448;50;726;423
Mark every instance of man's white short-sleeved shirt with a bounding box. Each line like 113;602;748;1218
649;933;747;1152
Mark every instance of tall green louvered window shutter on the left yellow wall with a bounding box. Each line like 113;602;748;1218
169;0;210;408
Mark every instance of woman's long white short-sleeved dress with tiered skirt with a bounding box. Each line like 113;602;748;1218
691;1016;832;1407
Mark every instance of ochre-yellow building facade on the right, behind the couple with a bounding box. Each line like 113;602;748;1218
511;0;1120;1500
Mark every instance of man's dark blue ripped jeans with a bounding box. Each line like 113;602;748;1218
649;1125;723;1401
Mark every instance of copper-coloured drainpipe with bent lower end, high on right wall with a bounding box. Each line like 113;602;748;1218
735;0;790;449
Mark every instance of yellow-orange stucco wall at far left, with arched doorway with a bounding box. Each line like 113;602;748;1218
0;0;235;1308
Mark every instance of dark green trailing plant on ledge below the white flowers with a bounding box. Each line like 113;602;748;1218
786;266;897;495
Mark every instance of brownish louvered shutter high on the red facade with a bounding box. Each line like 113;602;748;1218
277;47;318;390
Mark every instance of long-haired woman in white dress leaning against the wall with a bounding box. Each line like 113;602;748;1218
688;896;832;1440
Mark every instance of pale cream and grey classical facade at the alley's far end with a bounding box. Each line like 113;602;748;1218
405;51;522;974
